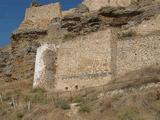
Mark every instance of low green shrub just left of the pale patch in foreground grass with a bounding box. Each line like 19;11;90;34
55;99;70;110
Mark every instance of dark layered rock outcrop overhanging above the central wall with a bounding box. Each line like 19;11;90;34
61;4;160;35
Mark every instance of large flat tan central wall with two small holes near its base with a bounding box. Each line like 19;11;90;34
56;29;111;90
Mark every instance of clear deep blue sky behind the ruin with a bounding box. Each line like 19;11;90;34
0;0;83;47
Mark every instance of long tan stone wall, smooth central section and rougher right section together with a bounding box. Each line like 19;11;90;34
32;17;160;91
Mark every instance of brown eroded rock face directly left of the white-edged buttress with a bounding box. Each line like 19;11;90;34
11;29;47;80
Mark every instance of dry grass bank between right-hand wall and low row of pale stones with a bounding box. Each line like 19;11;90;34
105;66;160;91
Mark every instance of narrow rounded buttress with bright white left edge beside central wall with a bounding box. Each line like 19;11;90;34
33;44;57;89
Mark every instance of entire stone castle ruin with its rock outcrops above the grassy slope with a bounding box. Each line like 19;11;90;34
11;0;160;91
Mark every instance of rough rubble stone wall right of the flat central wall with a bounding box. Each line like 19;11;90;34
116;35;160;77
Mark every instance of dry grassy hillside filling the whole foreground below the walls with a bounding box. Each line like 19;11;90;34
0;68;160;120
